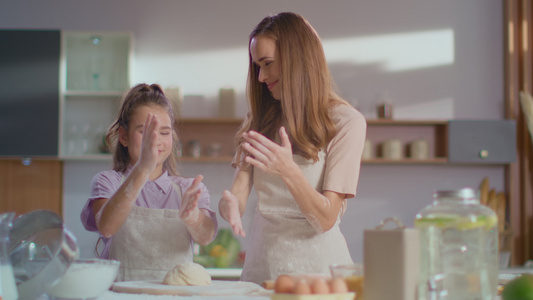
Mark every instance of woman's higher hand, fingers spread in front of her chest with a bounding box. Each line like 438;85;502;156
242;126;294;176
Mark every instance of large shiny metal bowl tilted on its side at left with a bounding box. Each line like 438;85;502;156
9;210;79;300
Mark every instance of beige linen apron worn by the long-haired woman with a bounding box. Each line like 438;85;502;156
241;151;353;284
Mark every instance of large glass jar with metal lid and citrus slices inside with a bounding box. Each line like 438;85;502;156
415;188;498;300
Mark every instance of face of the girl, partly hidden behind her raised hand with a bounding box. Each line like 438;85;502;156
120;105;172;168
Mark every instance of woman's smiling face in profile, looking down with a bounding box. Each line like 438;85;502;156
250;35;281;100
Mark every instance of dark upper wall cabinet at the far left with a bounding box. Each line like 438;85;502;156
0;30;60;157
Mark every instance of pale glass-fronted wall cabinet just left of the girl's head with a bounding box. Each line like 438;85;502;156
59;31;133;160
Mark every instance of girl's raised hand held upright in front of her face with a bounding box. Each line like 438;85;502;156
138;113;160;171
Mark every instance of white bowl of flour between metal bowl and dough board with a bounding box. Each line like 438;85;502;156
47;259;120;299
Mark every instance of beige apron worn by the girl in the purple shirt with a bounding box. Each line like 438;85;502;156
109;183;193;281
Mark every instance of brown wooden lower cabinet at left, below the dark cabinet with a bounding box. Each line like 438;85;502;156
0;159;63;216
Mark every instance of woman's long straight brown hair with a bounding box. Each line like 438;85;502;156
235;12;346;166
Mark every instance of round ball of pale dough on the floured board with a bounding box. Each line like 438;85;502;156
163;262;211;285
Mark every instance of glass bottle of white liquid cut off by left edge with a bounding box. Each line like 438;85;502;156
0;213;18;300
